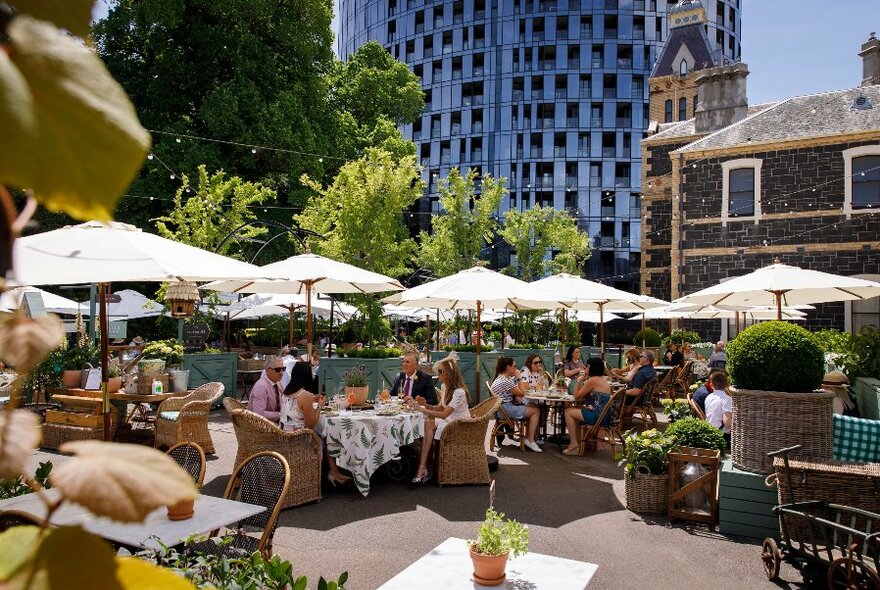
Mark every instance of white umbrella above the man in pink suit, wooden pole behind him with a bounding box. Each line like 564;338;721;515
201;254;403;354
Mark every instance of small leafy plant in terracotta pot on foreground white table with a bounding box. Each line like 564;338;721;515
468;507;529;586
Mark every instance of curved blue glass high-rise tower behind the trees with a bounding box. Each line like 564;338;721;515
337;0;742;290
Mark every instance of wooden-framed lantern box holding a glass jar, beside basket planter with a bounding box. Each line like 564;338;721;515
668;447;721;524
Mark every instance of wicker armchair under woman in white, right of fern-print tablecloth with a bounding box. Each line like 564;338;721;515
437;396;501;486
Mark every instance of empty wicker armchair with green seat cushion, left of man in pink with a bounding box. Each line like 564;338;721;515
155;383;223;453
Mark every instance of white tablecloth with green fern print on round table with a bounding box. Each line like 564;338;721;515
326;410;425;496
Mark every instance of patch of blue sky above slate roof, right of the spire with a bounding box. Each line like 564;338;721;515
742;0;880;104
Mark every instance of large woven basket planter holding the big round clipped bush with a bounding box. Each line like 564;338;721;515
730;389;834;473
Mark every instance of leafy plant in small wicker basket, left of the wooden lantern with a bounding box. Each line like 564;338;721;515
620;428;676;514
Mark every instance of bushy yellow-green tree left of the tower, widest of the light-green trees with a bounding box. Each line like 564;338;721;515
294;148;425;276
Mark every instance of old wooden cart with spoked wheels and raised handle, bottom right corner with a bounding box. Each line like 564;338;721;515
761;445;880;589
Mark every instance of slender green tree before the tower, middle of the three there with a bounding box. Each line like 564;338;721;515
419;168;507;277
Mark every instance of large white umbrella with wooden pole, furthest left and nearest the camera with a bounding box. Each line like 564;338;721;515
12;221;265;439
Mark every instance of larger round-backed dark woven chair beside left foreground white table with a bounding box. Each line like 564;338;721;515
223;451;290;556
